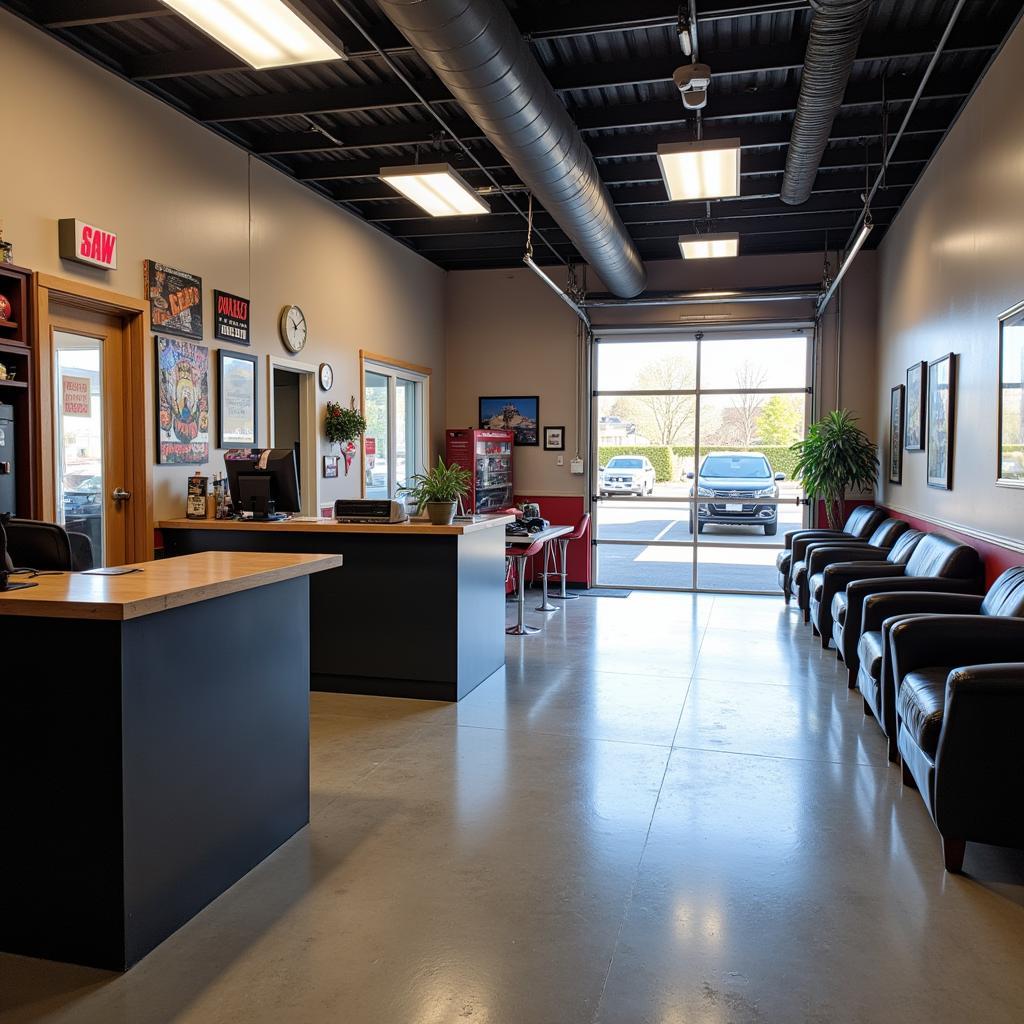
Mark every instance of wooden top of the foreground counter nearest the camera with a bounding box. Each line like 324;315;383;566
0;551;342;621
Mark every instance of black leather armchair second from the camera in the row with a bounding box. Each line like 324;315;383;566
857;565;1024;762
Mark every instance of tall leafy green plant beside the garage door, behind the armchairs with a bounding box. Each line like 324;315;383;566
790;409;879;529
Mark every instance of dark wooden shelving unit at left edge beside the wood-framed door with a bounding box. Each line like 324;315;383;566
0;263;37;517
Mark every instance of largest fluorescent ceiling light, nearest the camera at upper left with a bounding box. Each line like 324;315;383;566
164;0;344;70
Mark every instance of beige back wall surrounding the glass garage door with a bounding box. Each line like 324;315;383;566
445;252;877;495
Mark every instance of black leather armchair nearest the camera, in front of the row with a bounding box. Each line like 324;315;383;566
890;615;1024;871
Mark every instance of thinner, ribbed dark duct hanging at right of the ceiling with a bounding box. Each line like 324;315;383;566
781;0;871;206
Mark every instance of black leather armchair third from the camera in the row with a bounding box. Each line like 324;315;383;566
812;532;985;689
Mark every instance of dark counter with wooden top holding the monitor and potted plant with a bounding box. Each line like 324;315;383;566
159;516;512;700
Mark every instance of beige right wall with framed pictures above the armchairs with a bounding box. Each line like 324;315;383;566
878;14;1024;550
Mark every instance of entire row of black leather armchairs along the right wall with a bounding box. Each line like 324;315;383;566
776;506;1024;871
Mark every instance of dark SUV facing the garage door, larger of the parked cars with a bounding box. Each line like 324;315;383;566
686;452;785;537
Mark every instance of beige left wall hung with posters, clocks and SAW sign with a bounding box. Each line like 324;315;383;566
0;11;444;518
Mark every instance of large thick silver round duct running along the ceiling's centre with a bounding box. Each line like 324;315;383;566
377;0;646;298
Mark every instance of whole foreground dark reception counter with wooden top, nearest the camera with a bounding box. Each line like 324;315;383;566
0;553;342;970
